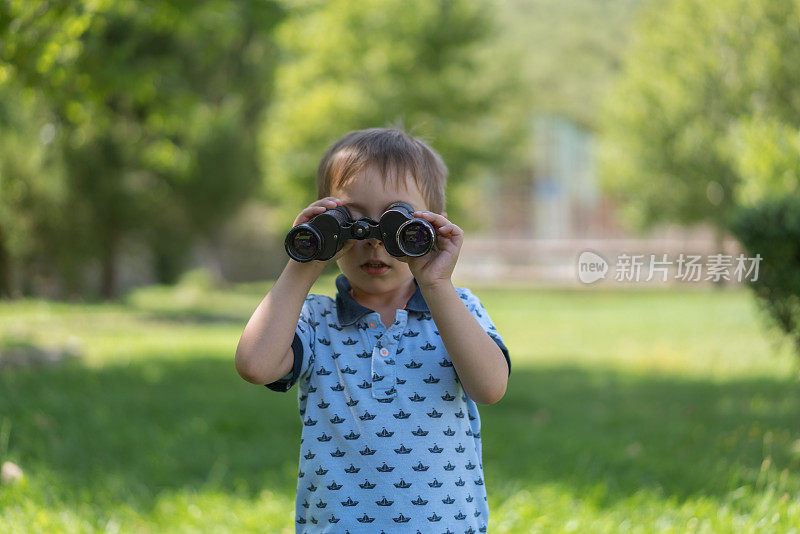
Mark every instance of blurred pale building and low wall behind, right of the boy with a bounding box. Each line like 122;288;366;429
454;113;740;285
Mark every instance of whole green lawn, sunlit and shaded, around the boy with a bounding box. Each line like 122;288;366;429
0;276;800;532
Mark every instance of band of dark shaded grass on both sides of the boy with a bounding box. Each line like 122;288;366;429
0;355;800;509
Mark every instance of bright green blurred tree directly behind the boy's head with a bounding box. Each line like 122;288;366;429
263;0;524;227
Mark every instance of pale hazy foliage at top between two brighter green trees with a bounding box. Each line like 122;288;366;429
494;0;652;131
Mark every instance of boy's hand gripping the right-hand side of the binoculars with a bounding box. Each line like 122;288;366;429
398;211;464;292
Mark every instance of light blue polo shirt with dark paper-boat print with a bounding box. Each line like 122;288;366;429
266;274;511;534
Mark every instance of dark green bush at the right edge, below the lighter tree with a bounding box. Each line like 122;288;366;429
731;195;800;355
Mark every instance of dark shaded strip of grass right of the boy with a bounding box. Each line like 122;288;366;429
480;367;800;508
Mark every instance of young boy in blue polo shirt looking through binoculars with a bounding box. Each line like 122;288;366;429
236;128;511;534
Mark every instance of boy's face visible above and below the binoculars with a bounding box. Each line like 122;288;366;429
331;166;428;294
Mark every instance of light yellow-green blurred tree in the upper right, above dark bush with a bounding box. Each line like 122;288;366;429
601;0;800;227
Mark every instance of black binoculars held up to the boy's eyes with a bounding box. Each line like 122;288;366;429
284;202;436;263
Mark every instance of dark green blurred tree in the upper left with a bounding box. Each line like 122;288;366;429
0;0;282;296
